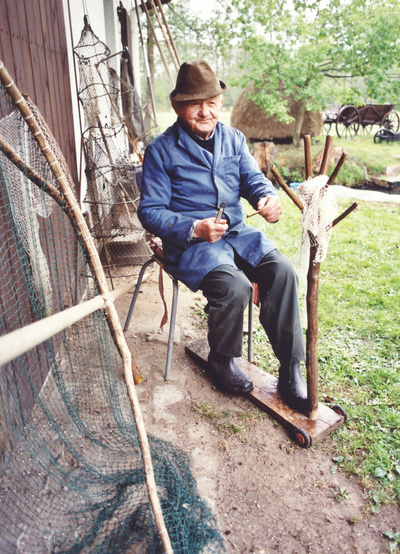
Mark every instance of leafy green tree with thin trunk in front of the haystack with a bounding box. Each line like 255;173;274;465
225;0;400;145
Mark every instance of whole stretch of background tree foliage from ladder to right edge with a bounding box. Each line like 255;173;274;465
152;0;400;142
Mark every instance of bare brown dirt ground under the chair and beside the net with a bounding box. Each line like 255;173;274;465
116;260;400;554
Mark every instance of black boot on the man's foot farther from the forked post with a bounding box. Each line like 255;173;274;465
208;351;254;393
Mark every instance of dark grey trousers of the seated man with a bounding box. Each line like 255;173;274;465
200;250;305;368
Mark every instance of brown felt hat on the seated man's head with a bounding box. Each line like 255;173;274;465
169;60;226;102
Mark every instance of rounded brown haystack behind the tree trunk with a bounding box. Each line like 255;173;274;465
231;89;323;142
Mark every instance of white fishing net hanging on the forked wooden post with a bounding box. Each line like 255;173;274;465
294;175;337;326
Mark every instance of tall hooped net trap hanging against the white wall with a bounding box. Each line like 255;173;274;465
74;20;151;279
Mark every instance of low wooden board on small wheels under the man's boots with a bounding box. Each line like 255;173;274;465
185;338;346;448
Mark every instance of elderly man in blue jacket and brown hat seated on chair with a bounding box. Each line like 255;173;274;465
138;60;307;410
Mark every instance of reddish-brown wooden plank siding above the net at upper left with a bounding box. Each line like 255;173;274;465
0;0;79;190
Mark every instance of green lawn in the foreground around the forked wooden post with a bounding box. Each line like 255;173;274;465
246;193;400;511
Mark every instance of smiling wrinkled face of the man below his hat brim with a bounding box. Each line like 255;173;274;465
172;96;224;139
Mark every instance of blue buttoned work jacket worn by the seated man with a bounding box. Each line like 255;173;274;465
138;120;277;291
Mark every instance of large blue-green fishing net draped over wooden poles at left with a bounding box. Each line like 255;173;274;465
0;62;224;553
